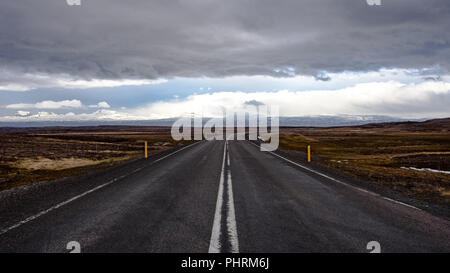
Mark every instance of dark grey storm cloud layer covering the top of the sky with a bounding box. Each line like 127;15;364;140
0;0;450;82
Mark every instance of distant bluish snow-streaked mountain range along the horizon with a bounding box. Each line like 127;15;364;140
0;115;426;127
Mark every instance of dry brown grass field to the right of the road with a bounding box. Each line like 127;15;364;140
280;121;450;203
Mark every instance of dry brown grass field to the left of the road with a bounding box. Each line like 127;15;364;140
0;127;187;190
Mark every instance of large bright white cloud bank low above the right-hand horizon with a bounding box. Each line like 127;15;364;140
133;81;450;119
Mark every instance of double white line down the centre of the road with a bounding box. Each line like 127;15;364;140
208;141;239;253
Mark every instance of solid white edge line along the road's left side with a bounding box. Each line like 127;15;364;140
0;139;199;235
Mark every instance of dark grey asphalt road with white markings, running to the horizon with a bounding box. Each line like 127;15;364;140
0;141;450;252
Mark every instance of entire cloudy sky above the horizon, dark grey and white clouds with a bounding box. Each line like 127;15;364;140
0;0;450;121
